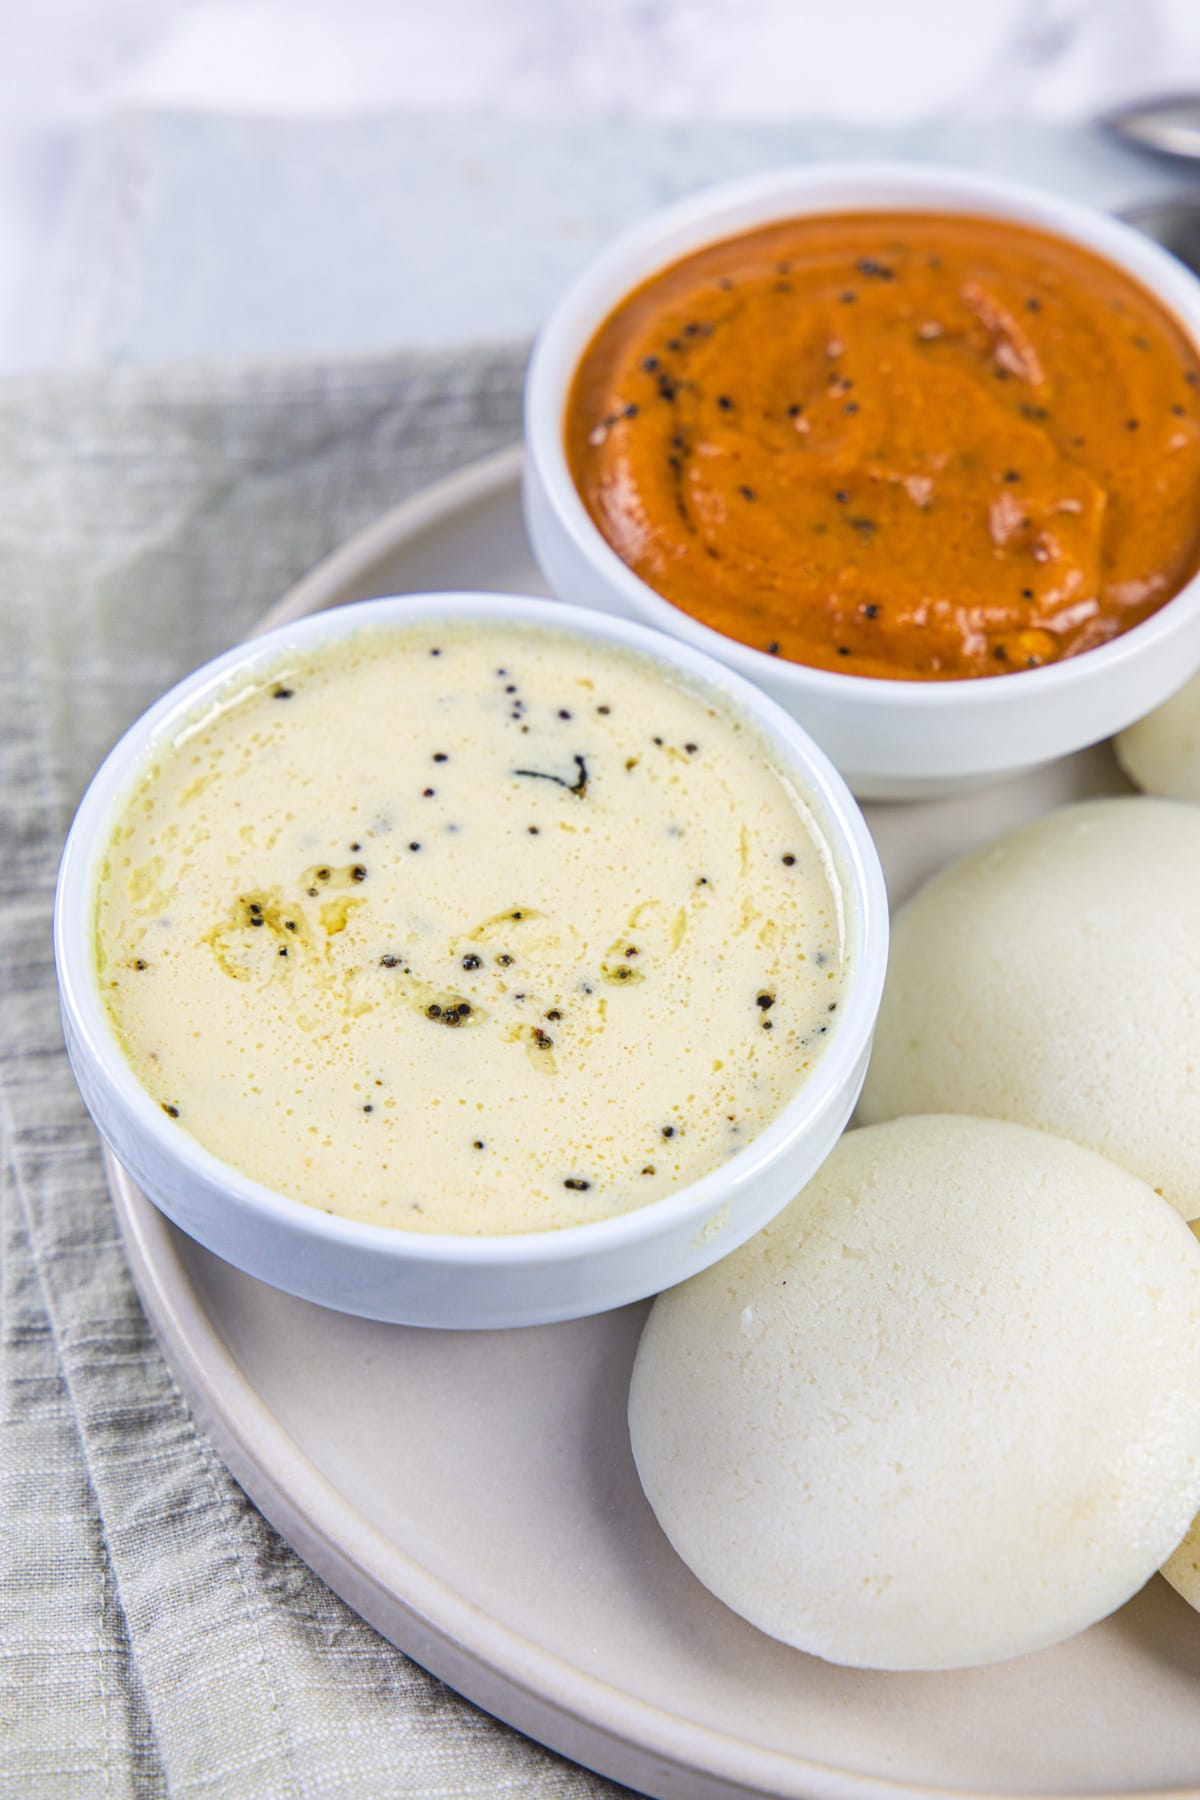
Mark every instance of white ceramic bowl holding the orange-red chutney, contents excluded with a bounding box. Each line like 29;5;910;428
525;164;1200;799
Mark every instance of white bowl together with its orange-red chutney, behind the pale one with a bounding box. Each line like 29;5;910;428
525;164;1200;797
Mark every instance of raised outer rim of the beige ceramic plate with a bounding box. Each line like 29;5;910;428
104;443;1200;1800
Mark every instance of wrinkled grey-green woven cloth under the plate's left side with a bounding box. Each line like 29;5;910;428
0;353;633;1800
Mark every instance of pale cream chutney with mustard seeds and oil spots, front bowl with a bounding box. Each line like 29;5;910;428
95;621;846;1235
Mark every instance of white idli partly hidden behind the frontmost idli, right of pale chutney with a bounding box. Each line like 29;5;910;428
858;796;1200;1219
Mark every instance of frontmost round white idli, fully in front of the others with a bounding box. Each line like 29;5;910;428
630;1116;1200;1669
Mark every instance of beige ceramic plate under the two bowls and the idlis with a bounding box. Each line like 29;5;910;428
103;452;1200;1800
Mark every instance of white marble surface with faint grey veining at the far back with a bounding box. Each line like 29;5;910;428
0;0;1200;367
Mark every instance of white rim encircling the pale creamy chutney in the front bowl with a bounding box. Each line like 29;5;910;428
54;592;889;1269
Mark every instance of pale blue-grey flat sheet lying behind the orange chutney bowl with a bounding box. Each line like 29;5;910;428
51;107;1198;367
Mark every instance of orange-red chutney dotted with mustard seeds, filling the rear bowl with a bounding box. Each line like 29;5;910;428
565;212;1200;680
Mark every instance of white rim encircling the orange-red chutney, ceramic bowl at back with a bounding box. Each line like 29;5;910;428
524;160;1200;713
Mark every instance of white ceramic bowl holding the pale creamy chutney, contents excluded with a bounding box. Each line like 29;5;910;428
54;594;887;1327
